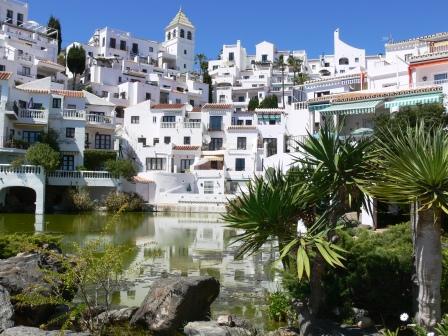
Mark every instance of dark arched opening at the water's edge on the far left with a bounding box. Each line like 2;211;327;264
0;187;36;213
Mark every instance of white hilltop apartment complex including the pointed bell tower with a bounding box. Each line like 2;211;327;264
67;10;208;117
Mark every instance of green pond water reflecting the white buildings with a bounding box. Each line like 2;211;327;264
0;213;278;330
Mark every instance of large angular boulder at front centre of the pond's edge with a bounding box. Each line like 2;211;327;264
131;276;220;335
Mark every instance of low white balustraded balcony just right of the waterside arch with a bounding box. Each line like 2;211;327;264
47;170;119;188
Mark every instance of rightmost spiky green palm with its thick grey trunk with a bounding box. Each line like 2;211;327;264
360;122;448;329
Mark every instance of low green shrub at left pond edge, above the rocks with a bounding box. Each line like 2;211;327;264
0;233;61;259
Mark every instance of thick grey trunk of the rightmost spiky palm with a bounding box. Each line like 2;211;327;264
414;209;442;330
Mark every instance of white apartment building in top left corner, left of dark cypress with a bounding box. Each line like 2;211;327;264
0;0;66;84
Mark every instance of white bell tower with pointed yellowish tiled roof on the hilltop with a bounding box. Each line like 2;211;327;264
164;8;196;72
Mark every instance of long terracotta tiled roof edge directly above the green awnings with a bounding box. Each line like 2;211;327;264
308;86;442;103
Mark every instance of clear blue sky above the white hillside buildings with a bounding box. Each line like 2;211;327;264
28;0;448;58
